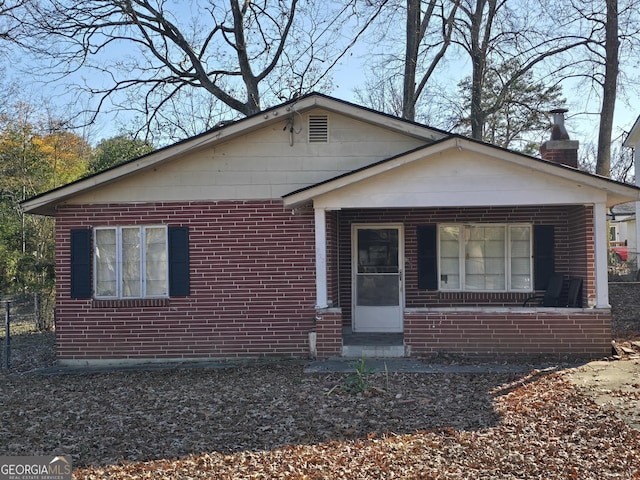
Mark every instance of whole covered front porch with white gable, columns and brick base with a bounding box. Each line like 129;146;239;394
285;138;638;358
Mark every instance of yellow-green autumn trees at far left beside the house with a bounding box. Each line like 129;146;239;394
0;103;89;293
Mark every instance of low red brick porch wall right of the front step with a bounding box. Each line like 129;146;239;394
404;309;611;358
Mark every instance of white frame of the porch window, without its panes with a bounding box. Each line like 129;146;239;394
438;223;534;293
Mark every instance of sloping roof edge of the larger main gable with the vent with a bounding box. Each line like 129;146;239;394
21;92;448;215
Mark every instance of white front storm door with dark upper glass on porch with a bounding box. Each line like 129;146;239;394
352;224;404;333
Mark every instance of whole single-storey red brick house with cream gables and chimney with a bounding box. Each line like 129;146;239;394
22;94;640;365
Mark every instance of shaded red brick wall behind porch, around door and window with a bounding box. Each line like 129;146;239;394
339;206;593;326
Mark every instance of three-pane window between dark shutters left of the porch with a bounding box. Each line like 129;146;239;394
94;226;169;298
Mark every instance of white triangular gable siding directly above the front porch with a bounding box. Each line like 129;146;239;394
314;148;606;210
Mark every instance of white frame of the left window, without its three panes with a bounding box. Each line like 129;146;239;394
93;225;169;300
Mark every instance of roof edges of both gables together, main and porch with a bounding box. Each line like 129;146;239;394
21;93;640;215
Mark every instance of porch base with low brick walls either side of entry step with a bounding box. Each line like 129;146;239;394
316;307;611;361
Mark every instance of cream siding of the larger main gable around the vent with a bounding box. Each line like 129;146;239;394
65;110;426;204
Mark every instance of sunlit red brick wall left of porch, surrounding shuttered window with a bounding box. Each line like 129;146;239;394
56;201;315;362
